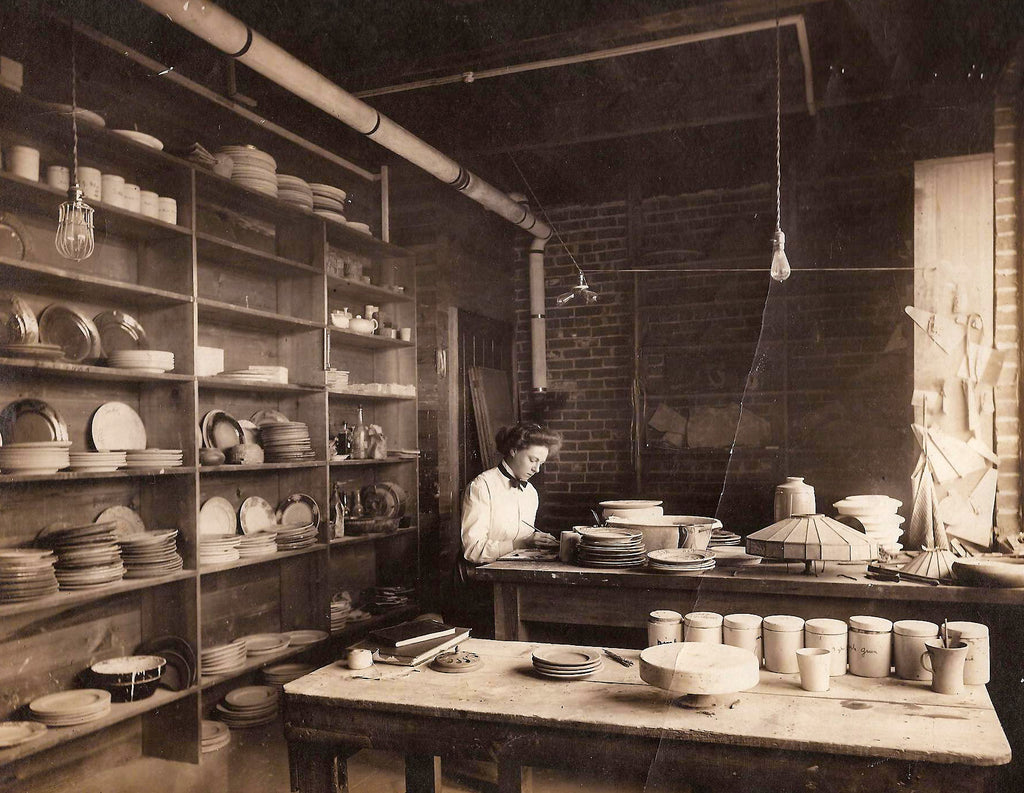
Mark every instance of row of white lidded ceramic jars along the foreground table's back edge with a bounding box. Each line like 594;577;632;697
647;610;989;685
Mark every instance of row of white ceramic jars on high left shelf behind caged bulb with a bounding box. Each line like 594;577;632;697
7;145;178;223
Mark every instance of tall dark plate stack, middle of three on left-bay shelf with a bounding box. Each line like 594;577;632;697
43;523;125;589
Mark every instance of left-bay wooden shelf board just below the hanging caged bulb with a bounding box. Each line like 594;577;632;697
0;256;193;305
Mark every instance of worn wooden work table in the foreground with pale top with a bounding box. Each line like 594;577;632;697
285;639;1010;793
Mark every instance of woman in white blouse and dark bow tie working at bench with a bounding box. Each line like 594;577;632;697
462;423;561;565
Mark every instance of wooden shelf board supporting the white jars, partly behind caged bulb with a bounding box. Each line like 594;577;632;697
0;172;191;242
